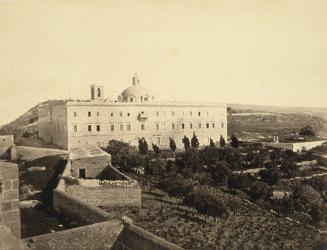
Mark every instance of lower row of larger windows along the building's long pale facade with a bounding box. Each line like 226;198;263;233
74;122;224;132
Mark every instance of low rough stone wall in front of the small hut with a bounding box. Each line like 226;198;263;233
66;181;141;207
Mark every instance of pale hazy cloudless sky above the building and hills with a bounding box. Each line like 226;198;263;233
0;0;327;124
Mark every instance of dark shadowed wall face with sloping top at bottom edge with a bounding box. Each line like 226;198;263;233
112;224;183;250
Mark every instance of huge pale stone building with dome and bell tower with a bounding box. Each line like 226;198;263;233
38;75;227;149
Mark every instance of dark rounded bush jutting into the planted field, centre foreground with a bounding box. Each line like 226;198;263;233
183;189;227;216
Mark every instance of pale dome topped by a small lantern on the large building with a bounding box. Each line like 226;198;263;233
118;74;153;102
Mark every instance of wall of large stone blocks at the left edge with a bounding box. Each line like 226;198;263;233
0;161;21;238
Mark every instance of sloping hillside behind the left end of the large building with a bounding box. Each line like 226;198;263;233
0;100;65;146
